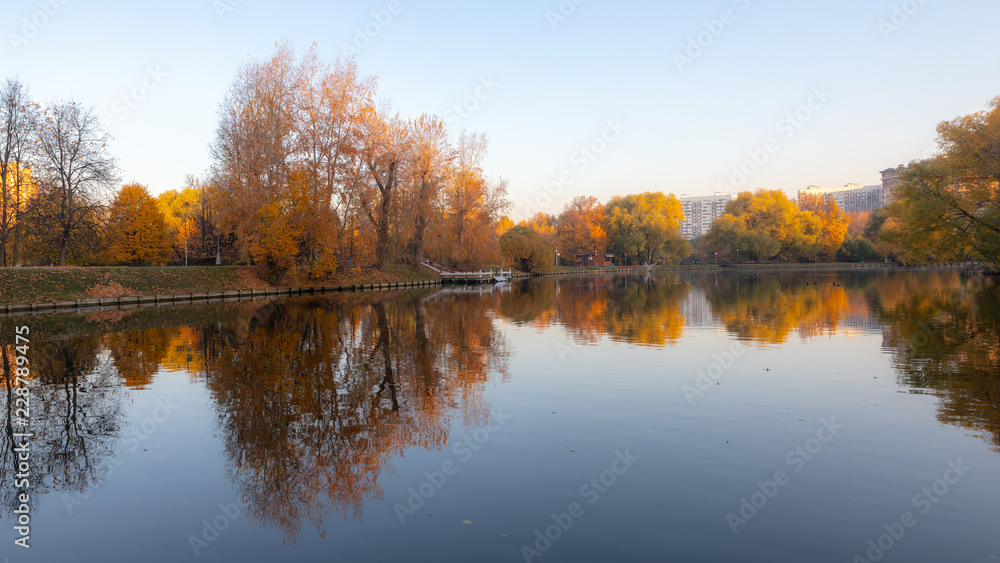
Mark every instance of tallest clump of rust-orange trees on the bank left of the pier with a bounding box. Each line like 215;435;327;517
210;43;507;277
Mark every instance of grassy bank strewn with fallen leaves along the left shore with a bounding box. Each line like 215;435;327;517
0;266;435;305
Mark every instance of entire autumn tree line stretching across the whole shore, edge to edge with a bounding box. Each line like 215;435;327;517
0;49;1000;278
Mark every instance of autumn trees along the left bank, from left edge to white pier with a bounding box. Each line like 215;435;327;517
0;43;510;278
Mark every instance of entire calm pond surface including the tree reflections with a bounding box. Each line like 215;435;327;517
0;272;1000;563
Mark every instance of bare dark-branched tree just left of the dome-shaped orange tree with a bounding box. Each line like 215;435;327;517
38;101;117;266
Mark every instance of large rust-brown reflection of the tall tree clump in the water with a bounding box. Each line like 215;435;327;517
197;292;509;540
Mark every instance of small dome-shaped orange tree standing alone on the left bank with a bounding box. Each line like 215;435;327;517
107;184;170;265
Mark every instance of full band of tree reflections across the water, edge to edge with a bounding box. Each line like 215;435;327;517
0;272;1000;541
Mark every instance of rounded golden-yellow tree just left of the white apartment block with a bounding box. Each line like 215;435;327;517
605;192;692;264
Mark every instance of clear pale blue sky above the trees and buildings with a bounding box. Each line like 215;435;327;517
0;0;1000;218
